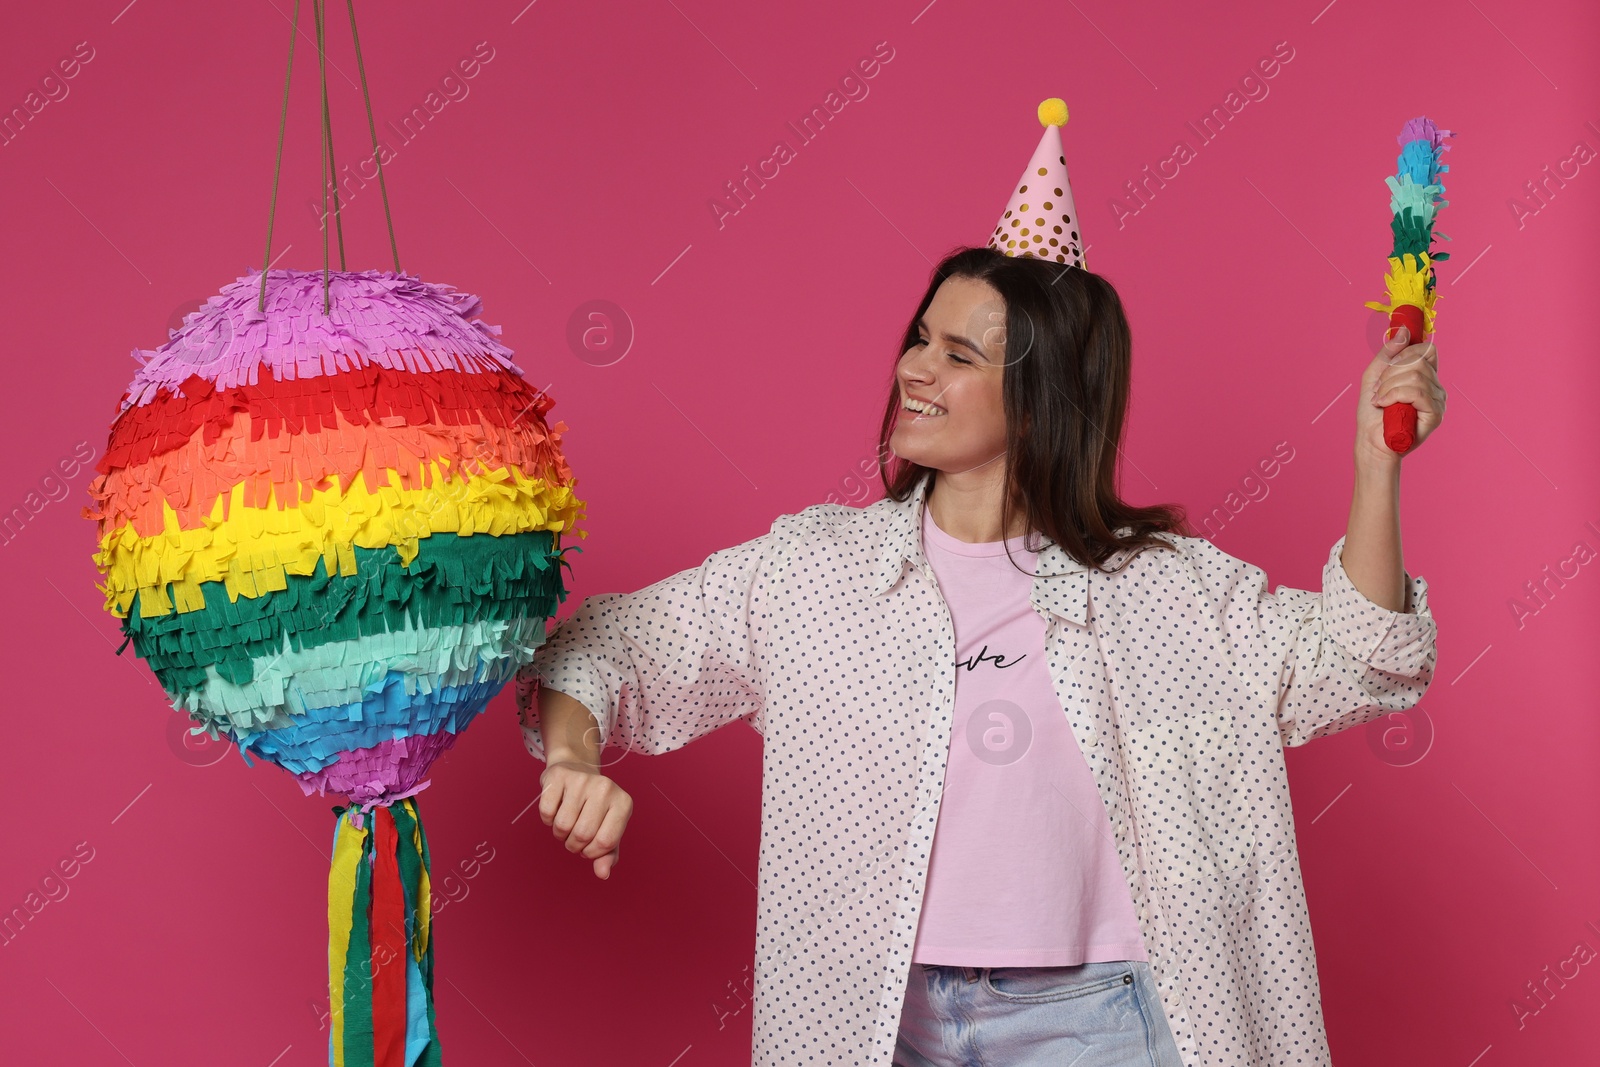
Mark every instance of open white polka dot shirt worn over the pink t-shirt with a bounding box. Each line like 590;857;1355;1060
517;478;1437;1067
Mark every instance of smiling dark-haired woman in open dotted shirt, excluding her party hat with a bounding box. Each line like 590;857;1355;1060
518;248;1443;1067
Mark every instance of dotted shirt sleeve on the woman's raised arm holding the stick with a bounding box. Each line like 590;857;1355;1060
1200;537;1438;747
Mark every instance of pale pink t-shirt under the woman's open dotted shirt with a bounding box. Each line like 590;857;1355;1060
912;509;1149;966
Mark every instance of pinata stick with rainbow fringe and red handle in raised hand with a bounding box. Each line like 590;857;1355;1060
1365;117;1456;453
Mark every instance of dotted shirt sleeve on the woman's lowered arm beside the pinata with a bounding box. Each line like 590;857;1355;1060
517;515;792;761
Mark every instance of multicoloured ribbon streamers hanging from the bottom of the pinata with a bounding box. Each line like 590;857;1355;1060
328;797;440;1067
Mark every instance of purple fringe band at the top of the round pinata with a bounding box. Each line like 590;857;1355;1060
122;269;522;410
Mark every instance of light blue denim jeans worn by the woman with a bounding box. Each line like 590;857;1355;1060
894;960;1184;1067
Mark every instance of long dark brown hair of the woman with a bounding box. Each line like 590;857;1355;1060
878;248;1194;568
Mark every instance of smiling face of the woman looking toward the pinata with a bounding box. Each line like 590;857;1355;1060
890;277;1006;474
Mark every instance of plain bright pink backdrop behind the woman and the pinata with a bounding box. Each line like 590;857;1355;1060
0;0;1600;1067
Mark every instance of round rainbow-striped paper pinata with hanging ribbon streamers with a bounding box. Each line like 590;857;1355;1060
85;270;582;1067
